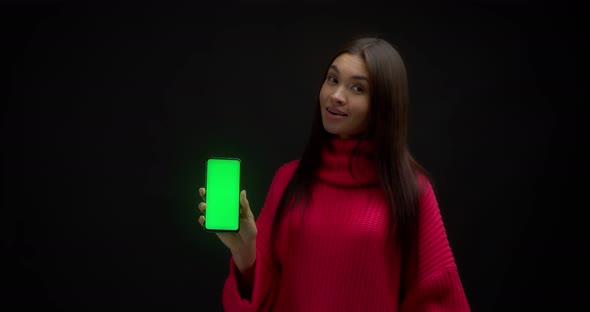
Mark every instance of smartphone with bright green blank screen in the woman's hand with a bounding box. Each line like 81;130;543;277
205;157;242;232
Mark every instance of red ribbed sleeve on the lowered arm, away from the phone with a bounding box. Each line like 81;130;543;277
401;179;470;312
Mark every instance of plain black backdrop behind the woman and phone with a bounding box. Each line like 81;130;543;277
1;1;588;311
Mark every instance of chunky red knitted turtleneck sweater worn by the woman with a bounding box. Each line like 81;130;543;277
222;138;470;312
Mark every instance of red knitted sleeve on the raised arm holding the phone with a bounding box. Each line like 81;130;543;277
222;160;298;312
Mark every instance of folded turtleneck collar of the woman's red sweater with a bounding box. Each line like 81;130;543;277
318;137;378;187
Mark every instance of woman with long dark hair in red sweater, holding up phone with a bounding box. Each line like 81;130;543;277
199;38;470;312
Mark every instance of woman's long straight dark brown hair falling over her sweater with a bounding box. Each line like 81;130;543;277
271;38;429;266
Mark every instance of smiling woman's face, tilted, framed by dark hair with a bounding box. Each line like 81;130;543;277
320;54;371;139
